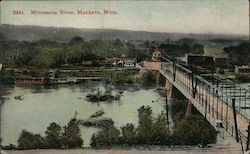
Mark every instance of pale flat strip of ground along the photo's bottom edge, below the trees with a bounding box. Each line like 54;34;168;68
5;144;242;154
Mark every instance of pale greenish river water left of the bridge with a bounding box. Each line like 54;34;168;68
1;82;168;147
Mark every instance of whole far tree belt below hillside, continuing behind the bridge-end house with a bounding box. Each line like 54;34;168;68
0;35;204;68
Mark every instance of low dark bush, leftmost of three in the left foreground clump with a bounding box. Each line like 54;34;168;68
17;130;43;150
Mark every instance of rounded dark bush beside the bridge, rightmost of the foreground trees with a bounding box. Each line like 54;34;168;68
175;115;216;147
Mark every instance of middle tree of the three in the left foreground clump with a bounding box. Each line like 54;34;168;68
44;122;62;149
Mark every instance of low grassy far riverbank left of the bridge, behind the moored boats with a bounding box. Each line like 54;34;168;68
1;67;139;84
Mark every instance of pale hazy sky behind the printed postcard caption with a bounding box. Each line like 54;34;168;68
1;0;249;35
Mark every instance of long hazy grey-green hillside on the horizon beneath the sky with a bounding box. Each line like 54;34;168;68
0;24;247;42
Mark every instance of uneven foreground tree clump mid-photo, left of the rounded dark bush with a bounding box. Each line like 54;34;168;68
91;106;171;148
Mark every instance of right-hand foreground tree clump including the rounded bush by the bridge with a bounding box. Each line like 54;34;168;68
91;106;216;149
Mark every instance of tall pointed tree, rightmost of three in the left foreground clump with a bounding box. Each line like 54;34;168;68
62;118;83;149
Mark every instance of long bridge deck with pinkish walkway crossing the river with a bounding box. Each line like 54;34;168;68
160;62;250;144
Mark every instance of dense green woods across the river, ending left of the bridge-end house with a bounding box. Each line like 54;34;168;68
0;36;152;68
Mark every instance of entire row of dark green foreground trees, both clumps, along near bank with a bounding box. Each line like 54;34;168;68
1;106;216;150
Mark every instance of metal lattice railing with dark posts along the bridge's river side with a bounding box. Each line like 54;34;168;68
161;60;250;141
